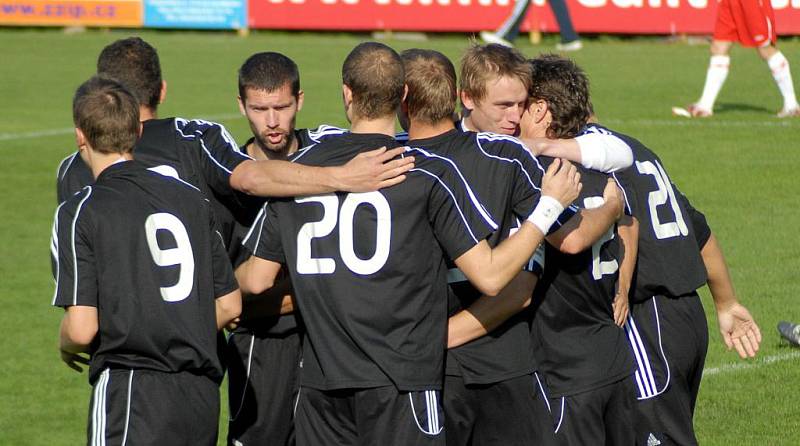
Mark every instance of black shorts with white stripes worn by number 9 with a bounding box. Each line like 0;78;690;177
87;369;219;446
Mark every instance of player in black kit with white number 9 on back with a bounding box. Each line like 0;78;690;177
53;77;241;446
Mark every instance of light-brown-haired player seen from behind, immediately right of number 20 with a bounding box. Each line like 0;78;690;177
399;49;621;445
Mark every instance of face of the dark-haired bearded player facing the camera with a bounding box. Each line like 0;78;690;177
239;84;303;154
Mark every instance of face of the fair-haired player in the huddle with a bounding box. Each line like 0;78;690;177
462;76;528;135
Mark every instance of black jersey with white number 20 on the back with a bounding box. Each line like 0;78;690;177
245;133;496;391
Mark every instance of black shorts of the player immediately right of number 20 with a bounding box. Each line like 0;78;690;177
442;374;555;446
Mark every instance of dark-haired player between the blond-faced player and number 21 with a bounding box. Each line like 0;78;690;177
521;55;637;445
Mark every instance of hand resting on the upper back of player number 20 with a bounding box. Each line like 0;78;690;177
335;147;414;192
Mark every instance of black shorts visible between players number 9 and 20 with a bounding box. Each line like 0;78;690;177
225;331;300;446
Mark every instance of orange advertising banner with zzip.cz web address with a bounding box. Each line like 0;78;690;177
0;0;142;27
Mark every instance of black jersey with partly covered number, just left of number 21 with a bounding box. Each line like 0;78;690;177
531;163;633;397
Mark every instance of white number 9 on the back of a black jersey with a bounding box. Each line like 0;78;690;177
144;212;194;302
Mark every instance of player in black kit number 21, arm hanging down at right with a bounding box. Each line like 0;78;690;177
535;56;761;445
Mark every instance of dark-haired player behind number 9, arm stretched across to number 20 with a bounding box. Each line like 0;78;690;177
57;37;409;208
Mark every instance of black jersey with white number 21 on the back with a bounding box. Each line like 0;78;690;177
584;125;707;303
